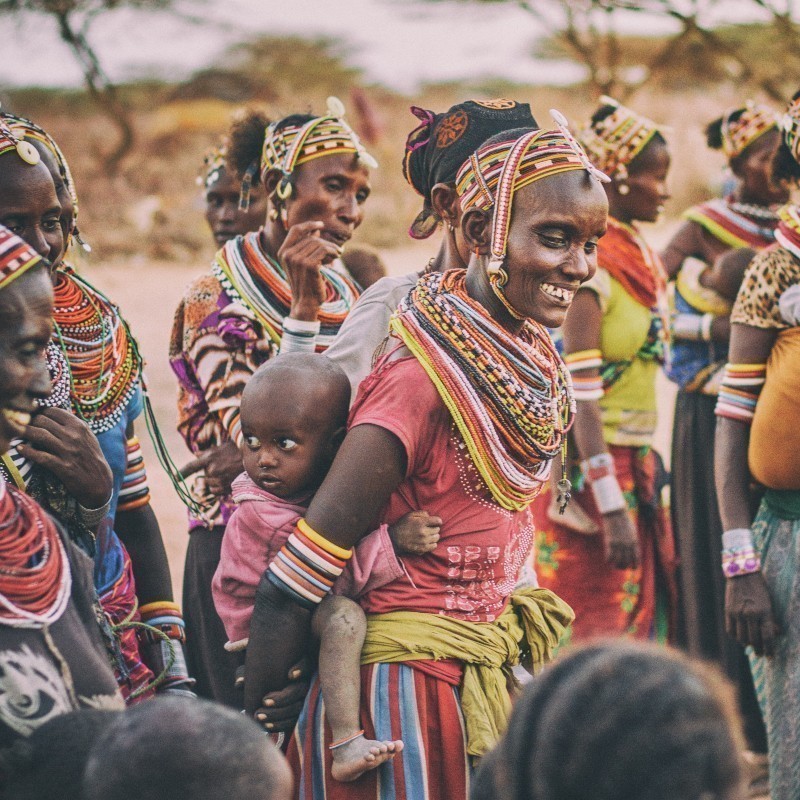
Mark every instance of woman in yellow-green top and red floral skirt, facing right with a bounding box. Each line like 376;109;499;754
534;98;676;641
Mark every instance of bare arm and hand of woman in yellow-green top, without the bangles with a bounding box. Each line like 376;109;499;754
564;289;639;569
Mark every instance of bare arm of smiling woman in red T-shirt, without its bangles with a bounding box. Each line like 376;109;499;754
245;425;406;715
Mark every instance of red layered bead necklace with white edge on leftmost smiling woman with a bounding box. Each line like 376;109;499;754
0;480;72;628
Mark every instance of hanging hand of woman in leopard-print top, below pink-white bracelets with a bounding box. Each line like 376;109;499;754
725;572;780;656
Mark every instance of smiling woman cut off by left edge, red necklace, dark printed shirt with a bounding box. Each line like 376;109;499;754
0;227;122;756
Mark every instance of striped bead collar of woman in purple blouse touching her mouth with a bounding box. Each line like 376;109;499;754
211;231;358;352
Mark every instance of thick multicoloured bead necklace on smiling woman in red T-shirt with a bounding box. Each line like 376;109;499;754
391;269;576;511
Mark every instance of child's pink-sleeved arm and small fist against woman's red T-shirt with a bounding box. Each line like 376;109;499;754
334;511;442;598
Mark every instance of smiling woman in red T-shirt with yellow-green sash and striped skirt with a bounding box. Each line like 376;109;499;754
245;120;607;800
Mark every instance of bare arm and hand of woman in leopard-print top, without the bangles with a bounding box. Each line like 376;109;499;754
714;324;778;655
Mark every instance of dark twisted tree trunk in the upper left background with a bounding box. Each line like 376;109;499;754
0;0;181;173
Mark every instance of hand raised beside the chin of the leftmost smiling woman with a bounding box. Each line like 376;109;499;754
19;408;114;508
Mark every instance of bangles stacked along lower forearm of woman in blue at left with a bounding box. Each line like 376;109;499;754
139;600;195;695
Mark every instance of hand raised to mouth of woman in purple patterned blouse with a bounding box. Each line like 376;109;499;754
278;220;342;322
